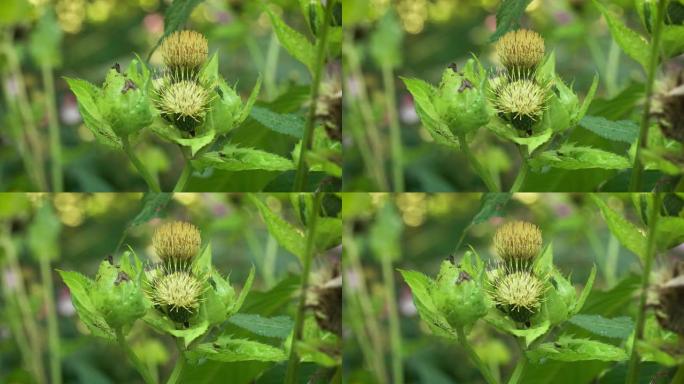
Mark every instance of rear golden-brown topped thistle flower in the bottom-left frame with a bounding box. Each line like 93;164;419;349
152;221;202;261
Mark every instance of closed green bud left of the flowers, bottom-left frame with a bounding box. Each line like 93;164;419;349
90;260;146;329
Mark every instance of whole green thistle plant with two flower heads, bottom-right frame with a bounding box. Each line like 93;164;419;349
400;221;616;384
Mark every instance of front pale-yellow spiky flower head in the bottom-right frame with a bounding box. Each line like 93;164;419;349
492;272;545;323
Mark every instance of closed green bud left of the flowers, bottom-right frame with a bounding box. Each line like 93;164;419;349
431;260;492;327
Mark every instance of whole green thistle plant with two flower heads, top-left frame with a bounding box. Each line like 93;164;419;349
67;30;264;192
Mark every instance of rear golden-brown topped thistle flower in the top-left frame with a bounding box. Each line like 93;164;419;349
161;31;209;70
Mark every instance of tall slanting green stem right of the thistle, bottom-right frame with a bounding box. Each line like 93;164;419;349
626;193;662;384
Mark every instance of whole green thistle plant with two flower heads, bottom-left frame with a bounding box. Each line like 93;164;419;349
59;221;286;384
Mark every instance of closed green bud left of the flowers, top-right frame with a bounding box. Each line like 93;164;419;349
434;59;489;135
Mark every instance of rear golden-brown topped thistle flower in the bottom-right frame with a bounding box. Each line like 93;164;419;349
494;221;542;270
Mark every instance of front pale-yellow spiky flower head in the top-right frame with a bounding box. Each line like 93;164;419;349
493;79;548;135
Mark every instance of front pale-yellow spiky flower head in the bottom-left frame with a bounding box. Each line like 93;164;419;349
149;271;204;323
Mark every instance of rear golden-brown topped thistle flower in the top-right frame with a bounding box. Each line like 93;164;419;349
496;29;544;71
